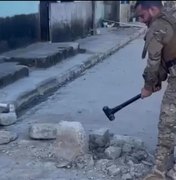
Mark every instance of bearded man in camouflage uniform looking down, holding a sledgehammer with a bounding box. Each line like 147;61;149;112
135;1;176;180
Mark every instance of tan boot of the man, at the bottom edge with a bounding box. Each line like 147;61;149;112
143;169;166;180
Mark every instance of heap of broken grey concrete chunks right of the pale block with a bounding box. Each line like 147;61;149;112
89;129;154;180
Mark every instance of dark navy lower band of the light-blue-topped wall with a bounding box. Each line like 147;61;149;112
0;14;39;53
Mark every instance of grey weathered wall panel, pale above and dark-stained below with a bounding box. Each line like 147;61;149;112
50;1;93;42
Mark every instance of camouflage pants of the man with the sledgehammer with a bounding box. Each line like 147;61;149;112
155;77;176;171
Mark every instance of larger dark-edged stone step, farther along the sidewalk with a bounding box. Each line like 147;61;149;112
2;42;79;68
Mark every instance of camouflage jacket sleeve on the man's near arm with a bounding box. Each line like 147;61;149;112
143;21;172;91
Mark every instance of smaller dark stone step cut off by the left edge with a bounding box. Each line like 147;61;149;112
0;62;29;88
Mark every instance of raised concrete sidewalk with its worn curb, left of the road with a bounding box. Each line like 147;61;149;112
0;27;146;114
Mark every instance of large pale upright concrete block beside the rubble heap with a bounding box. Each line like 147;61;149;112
55;121;88;162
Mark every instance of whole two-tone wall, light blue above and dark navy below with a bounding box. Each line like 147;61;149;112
0;1;39;53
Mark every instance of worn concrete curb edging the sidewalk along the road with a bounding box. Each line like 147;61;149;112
14;28;145;115
